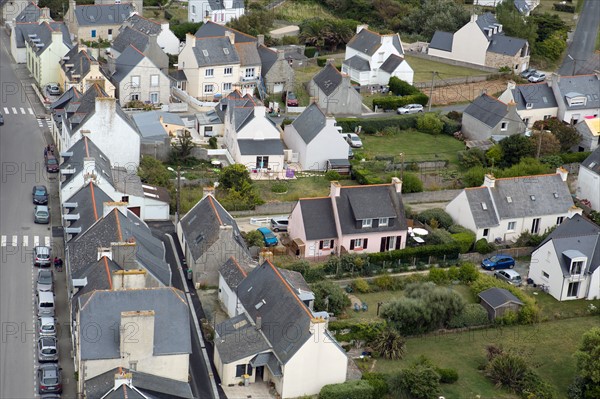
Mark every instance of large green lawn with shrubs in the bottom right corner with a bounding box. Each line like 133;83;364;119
375;317;600;399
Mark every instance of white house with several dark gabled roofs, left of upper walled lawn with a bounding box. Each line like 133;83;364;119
342;25;414;86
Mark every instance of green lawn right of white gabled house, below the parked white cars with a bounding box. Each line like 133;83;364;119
354;130;465;163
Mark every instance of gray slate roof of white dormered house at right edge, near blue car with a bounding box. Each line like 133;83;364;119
538;214;600;277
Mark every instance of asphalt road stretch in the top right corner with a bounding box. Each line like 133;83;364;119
558;0;600;76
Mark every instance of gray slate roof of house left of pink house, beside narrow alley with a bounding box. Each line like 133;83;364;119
179;194;248;259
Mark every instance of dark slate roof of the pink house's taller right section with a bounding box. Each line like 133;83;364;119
336;184;408;238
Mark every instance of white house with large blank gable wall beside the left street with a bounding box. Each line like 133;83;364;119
52;84;140;170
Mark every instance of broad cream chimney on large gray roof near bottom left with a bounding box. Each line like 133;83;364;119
119;310;155;362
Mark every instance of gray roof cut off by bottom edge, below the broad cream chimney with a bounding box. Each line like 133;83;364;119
85;367;194;399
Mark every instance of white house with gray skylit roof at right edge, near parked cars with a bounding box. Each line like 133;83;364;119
549;72;600;125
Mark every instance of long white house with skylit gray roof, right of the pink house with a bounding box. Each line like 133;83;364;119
446;168;581;242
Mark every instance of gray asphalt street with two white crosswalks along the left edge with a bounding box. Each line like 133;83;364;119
0;35;51;399
